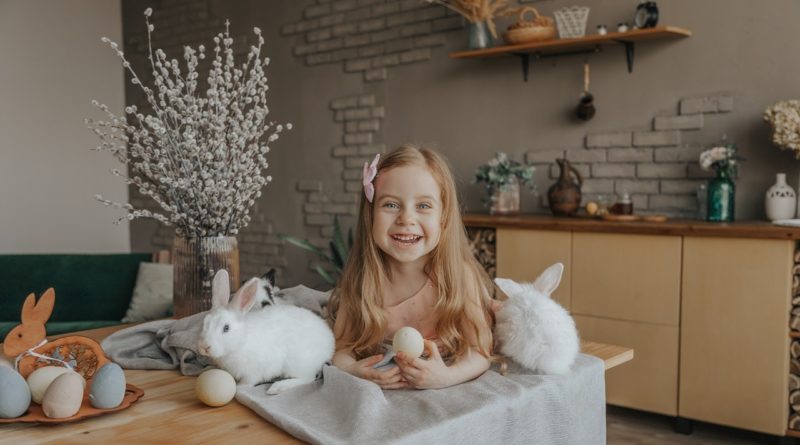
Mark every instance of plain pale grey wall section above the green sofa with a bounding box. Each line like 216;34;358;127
0;0;131;253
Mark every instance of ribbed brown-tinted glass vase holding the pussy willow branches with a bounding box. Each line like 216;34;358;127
172;236;239;318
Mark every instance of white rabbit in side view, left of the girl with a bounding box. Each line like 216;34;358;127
203;270;334;394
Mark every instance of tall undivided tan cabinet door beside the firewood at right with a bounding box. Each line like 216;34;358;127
676;237;794;435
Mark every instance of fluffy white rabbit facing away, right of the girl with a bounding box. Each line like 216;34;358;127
494;263;580;374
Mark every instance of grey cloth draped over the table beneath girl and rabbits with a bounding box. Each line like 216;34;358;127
102;288;606;445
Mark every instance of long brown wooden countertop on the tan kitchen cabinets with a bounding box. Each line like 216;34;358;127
463;213;800;240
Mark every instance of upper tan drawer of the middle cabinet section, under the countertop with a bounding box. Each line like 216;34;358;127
572;233;681;326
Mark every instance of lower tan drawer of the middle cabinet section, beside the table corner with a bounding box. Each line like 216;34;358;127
574;316;678;416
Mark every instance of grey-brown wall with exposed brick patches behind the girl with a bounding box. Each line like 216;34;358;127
123;0;800;285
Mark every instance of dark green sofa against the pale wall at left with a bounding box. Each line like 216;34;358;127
0;253;152;342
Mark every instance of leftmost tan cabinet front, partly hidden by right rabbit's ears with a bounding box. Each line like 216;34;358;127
496;229;572;310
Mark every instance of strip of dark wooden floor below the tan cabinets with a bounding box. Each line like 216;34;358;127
606;406;797;445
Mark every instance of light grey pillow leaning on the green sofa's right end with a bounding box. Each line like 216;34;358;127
122;263;172;323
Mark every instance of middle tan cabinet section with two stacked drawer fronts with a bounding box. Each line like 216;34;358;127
572;233;681;416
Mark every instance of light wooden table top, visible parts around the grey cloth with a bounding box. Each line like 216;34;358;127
0;325;633;445
